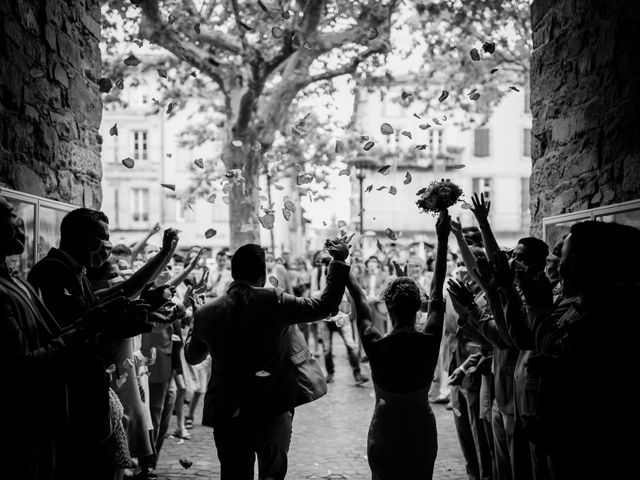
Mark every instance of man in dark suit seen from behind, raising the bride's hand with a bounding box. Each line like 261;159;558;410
185;240;349;480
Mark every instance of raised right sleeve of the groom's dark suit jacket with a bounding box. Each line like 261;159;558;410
276;261;349;324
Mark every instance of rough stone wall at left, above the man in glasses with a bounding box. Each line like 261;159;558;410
0;0;102;208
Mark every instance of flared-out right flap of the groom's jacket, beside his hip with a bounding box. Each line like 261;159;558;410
289;325;327;408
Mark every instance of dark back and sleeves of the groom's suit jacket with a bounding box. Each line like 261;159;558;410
185;261;349;426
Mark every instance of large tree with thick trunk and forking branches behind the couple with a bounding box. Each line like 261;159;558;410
102;0;399;248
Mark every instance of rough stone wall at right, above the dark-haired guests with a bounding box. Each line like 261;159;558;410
531;0;640;235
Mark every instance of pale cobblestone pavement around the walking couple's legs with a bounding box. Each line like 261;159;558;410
157;344;467;480
